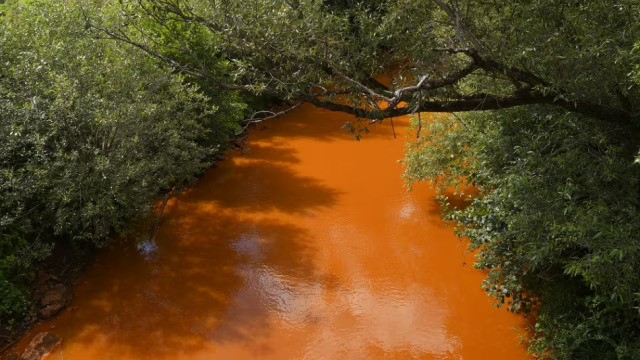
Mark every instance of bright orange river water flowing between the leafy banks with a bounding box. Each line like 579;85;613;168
8;105;528;360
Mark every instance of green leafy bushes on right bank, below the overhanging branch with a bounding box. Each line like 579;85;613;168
406;107;640;359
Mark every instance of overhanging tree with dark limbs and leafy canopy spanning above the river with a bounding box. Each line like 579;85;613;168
90;0;640;133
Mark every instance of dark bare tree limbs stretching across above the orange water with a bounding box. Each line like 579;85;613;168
87;0;638;126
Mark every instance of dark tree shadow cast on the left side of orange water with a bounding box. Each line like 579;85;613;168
50;139;339;358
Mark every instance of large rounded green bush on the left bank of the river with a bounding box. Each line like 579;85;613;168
0;0;244;321
